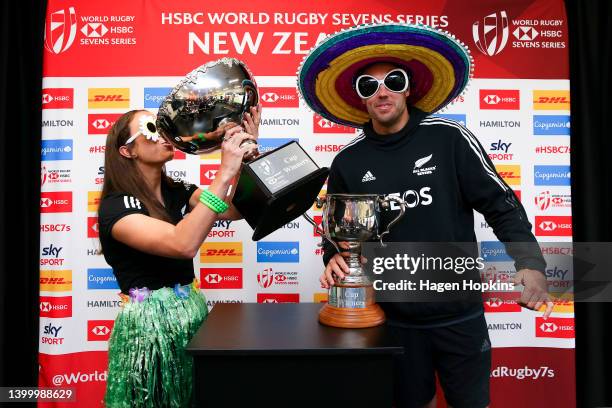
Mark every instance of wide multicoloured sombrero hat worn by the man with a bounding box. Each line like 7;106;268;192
297;23;474;127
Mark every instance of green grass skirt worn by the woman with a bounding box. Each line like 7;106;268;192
104;285;208;407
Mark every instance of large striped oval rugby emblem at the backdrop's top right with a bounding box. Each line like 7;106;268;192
472;11;509;57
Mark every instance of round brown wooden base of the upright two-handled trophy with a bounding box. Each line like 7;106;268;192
319;303;385;329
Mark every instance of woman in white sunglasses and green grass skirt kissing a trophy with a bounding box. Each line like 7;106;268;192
98;107;260;407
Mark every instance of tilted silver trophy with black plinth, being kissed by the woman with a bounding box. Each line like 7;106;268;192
157;58;329;241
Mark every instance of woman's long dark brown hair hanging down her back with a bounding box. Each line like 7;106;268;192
102;110;178;221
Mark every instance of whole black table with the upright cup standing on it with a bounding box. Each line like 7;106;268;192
187;303;402;408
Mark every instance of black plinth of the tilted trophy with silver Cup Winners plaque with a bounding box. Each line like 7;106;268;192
232;141;329;241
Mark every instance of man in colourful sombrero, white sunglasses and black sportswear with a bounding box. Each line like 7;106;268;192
299;24;552;408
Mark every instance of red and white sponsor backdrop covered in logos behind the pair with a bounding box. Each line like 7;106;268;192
40;0;575;407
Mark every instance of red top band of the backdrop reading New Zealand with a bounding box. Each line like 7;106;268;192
44;0;568;79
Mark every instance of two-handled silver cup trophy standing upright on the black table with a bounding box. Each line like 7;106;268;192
305;194;406;328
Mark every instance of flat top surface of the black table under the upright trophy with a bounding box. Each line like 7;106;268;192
187;303;402;355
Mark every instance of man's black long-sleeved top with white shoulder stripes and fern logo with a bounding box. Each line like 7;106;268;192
323;107;546;325
